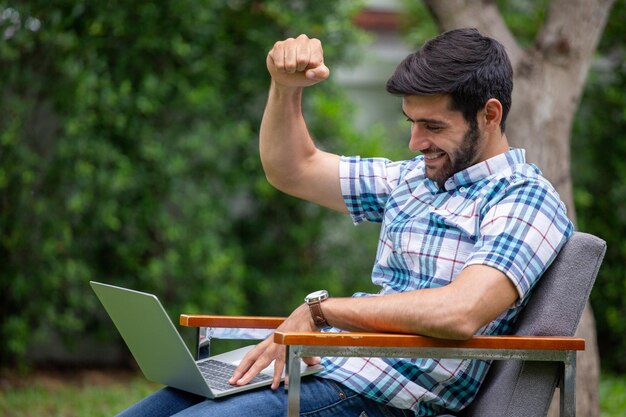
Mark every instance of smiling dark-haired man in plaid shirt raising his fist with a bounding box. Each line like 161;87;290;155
117;29;572;416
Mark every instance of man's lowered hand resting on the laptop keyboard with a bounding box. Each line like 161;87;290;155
228;304;320;389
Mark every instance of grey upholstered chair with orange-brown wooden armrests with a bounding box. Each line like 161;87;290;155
180;232;606;417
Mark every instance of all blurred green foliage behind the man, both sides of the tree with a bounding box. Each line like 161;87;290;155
0;0;626;372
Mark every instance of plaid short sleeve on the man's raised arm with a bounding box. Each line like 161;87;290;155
339;156;404;224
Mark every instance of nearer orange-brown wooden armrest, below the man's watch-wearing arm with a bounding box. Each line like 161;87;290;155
274;332;585;350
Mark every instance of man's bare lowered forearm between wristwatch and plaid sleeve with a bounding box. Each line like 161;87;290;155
322;265;518;339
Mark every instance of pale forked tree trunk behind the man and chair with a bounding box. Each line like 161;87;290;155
424;0;613;417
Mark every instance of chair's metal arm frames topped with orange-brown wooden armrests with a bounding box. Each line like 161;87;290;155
180;314;585;417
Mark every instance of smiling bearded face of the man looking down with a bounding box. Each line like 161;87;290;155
402;96;486;188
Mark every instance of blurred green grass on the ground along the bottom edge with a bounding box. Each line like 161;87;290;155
0;370;626;417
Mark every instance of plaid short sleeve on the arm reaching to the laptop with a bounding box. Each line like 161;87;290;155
465;178;573;306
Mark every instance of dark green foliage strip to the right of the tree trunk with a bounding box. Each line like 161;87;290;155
572;0;626;373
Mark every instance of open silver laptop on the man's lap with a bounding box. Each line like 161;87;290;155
89;281;323;398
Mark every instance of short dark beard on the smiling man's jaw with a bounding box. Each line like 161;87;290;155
426;120;481;189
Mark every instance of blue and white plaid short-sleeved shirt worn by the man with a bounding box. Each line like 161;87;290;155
322;149;573;416
